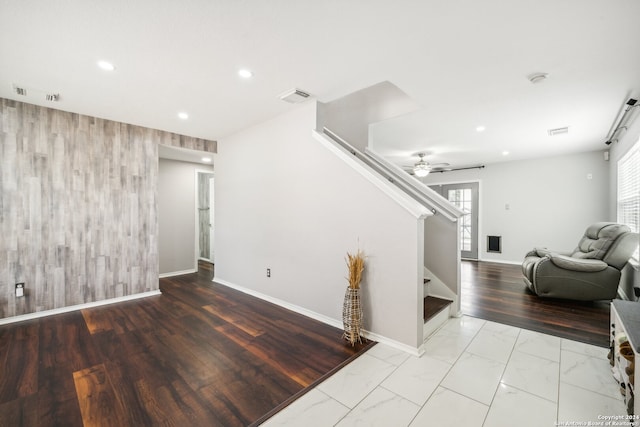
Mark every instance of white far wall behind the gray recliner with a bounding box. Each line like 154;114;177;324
424;152;611;263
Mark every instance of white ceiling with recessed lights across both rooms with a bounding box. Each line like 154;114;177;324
0;0;640;169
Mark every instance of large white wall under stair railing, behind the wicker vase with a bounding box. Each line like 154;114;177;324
214;103;424;348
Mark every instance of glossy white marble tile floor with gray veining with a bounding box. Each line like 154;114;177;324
262;317;626;427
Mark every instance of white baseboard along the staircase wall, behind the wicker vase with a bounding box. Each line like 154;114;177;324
213;277;424;357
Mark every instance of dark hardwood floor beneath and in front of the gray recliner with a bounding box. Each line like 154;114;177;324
462;261;610;347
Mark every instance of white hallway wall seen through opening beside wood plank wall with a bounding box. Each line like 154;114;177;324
158;159;213;275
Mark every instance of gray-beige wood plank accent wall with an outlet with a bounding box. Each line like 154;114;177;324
0;99;217;318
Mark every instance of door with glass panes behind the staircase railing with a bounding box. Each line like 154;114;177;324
429;182;478;259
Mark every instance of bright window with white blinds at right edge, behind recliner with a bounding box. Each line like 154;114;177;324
617;138;640;260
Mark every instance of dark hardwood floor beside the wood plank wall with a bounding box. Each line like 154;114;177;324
0;266;373;427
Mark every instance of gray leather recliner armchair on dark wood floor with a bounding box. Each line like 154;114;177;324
522;222;638;301
